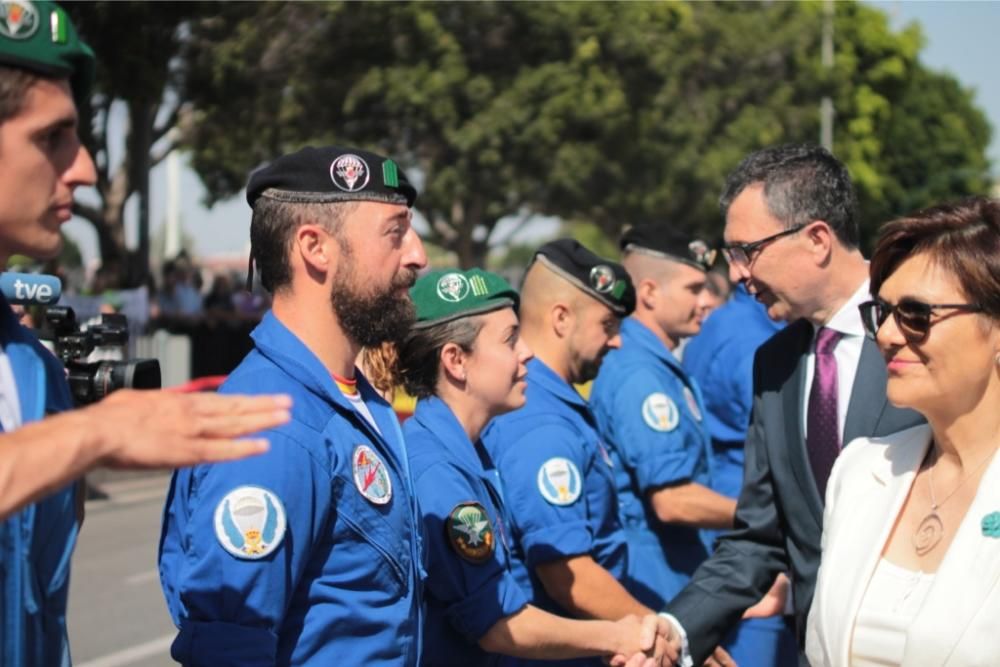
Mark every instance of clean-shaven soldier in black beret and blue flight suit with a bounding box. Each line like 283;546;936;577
590;225;735;608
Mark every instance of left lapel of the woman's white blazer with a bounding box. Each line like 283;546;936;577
823;427;930;665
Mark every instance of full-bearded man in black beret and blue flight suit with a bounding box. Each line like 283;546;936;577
160;147;426;667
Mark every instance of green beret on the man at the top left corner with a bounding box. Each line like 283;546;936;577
0;0;94;101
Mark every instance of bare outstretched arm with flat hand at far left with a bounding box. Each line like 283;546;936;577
0;390;291;518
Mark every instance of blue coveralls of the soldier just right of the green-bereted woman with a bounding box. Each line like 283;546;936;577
482;358;629;665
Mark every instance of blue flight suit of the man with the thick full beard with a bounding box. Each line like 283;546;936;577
160;312;422;667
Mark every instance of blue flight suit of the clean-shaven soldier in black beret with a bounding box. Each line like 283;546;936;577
590;317;712;609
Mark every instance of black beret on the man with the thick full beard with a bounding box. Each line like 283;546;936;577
247;146;417;208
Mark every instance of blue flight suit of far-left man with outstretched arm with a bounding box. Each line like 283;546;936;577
0;296;80;667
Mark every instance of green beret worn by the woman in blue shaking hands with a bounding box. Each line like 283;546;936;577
410;269;520;329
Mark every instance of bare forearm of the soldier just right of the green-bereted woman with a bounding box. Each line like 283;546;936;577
535;554;652;620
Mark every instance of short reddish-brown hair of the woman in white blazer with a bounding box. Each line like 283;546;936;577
870;197;1000;319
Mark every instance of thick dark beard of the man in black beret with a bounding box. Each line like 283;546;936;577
330;260;417;347
